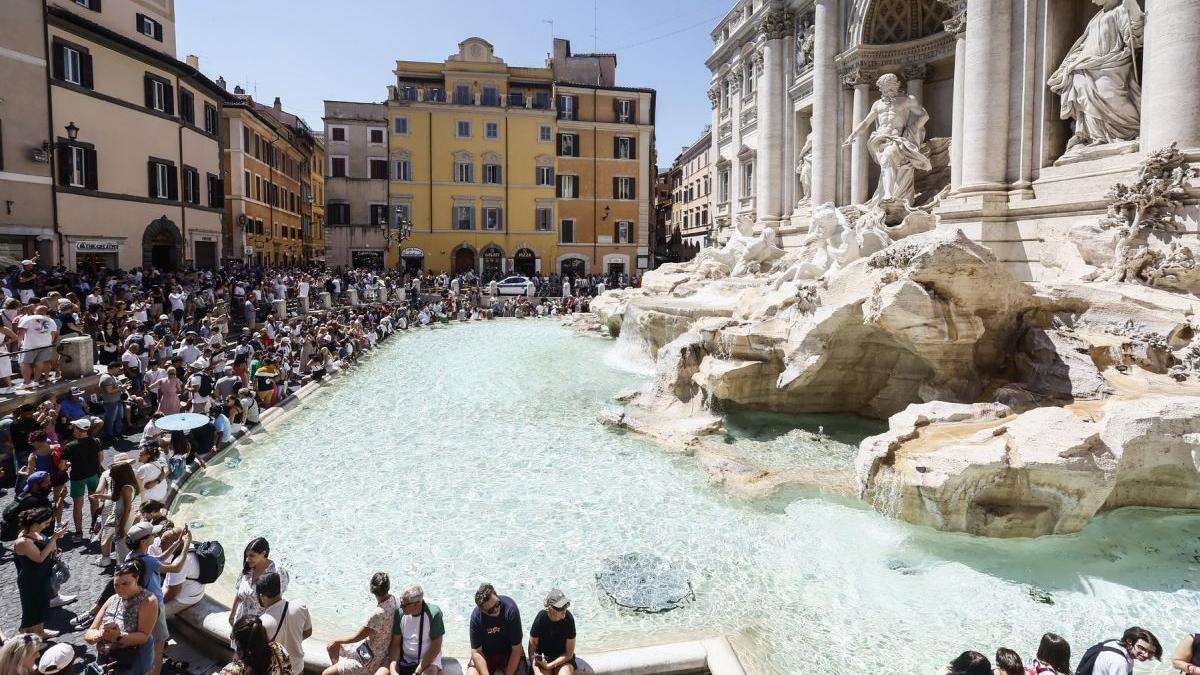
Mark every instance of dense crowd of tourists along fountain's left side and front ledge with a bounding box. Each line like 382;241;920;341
0;259;604;675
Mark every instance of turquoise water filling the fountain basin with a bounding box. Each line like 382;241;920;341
178;321;1200;675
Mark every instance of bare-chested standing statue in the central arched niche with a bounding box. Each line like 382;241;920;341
842;73;930;205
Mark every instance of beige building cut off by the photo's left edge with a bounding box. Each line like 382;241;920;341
0;0;54;263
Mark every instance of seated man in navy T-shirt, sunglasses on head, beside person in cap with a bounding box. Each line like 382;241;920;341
467;584;528;675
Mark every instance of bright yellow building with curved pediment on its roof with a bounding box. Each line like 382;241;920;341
388;37;557;279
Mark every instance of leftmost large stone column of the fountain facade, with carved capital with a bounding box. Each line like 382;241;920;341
755;7;792;226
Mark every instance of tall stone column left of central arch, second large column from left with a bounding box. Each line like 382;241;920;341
812;0;841;205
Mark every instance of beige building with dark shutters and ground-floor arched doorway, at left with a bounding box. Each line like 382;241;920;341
44;0;224;269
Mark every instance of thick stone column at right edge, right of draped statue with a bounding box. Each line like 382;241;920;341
1141;0;1200;153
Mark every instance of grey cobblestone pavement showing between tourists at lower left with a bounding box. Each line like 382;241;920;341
0;431;224;675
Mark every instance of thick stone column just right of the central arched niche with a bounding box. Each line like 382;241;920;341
959;0;1013;192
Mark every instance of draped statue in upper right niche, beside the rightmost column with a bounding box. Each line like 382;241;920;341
1046;0;1146;153
